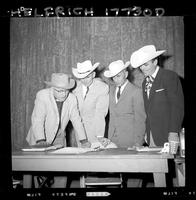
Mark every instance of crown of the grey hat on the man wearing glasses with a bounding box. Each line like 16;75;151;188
51;73;70;88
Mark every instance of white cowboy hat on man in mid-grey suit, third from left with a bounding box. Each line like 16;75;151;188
104;60;130;78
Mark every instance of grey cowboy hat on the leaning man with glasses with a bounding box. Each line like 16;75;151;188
45;73;75;89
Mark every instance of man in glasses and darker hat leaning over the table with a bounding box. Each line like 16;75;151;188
26;73;91;188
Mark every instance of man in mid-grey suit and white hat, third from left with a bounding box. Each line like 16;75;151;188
104;60;146;187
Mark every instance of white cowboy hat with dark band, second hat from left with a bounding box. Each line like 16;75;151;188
72;60;100;78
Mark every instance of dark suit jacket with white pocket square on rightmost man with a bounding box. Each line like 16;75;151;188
142;68;184;146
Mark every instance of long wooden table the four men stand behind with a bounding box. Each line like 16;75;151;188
12;148;174;188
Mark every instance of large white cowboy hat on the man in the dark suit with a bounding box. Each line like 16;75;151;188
130;45;165;68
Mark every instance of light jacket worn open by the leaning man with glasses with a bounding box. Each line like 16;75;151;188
26;88;86;145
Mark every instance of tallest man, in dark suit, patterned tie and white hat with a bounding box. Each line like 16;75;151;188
130;45;184;146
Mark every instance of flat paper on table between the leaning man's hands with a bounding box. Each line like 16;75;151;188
51;147;96;154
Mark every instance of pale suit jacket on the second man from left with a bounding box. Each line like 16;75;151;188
73;78;109;143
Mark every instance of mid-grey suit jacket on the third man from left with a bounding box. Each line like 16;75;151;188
108;81;146;147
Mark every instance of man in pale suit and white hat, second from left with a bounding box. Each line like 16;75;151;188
72;60;112;147
